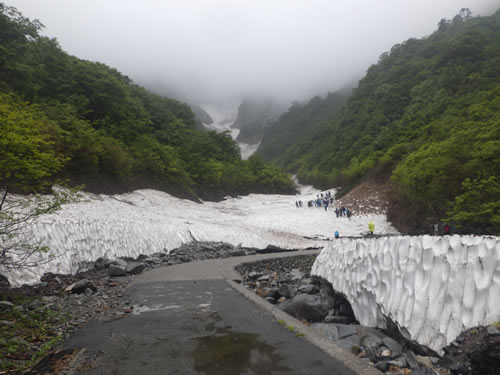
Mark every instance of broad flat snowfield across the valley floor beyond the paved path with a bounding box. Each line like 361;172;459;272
0;187;397;284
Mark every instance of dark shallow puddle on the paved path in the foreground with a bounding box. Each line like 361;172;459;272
192;331;290;375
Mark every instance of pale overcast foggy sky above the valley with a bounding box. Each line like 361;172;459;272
5;0;500;103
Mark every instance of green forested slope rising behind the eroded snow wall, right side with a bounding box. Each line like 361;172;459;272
258;9;500;234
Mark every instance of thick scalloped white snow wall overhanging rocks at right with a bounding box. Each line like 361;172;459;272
312;235;500;354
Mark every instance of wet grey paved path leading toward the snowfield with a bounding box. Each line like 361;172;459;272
61;251;376;375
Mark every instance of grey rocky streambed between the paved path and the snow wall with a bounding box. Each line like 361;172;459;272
237;255;500;375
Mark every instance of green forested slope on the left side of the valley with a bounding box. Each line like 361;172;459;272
0;3;294;198
